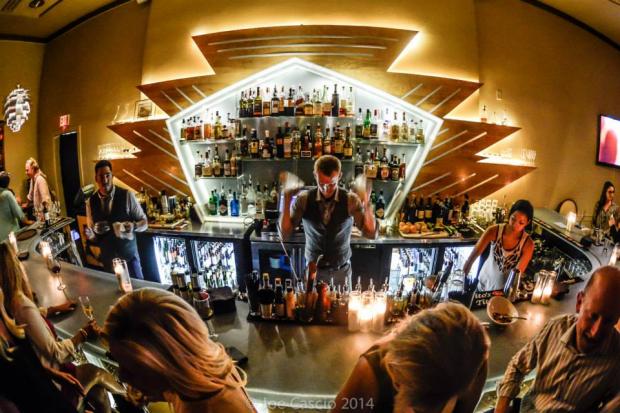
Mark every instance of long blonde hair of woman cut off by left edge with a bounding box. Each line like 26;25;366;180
0;241;34;317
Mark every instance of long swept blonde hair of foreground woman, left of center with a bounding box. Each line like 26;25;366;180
103;288;246;402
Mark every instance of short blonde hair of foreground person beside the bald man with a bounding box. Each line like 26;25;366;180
385;303;490;413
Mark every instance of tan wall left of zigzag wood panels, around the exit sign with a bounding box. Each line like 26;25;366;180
39;2;149;193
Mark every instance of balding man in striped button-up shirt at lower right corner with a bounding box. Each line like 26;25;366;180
495;266;620;413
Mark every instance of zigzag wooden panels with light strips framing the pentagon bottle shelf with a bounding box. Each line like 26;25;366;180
109;25;535;199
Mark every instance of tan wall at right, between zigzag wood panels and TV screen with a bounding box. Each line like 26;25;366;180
476;0;620;215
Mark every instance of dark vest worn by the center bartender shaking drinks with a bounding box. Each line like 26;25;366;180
302;188;353;268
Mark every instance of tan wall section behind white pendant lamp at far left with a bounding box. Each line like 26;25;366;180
0;40;45;197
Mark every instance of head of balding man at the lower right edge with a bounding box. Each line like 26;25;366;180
575;266;620;353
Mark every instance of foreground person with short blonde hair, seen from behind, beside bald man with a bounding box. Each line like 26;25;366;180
332;303;490;413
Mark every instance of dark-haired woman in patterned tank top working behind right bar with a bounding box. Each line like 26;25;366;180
463;199;534;291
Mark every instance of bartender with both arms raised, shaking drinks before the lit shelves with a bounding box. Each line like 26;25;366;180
280;155;377;286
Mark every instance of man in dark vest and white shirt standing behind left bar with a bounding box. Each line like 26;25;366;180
85;160;148;279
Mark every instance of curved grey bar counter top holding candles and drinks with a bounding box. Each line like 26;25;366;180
14;211;609;407
